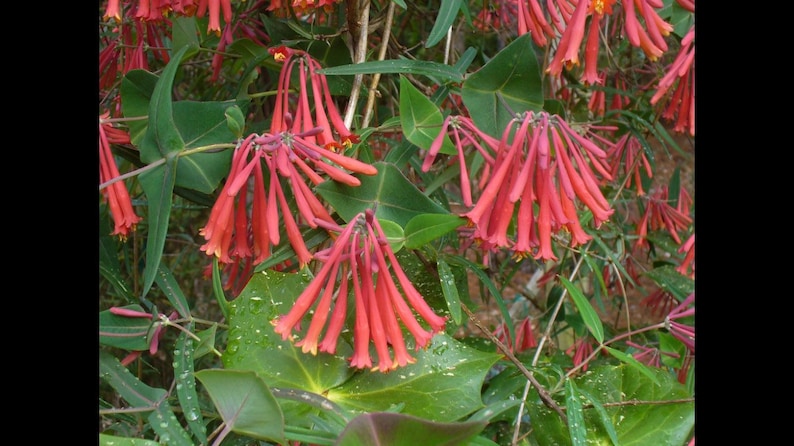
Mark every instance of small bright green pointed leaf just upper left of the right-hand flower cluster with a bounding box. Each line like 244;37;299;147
400;76;458;155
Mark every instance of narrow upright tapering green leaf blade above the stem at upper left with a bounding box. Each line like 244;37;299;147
140;47;188;160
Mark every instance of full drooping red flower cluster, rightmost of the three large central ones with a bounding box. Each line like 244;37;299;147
424;112;614;260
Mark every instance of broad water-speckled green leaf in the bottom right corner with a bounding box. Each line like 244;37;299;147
527;365;695;446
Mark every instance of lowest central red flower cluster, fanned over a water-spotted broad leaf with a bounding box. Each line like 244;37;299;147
274;210;446;372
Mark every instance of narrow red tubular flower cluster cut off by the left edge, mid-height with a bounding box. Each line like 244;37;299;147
99;113;142;240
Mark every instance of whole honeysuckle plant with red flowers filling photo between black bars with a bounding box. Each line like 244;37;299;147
98;0;695;446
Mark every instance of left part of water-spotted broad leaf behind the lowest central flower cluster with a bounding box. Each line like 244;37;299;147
222;270;353;395
